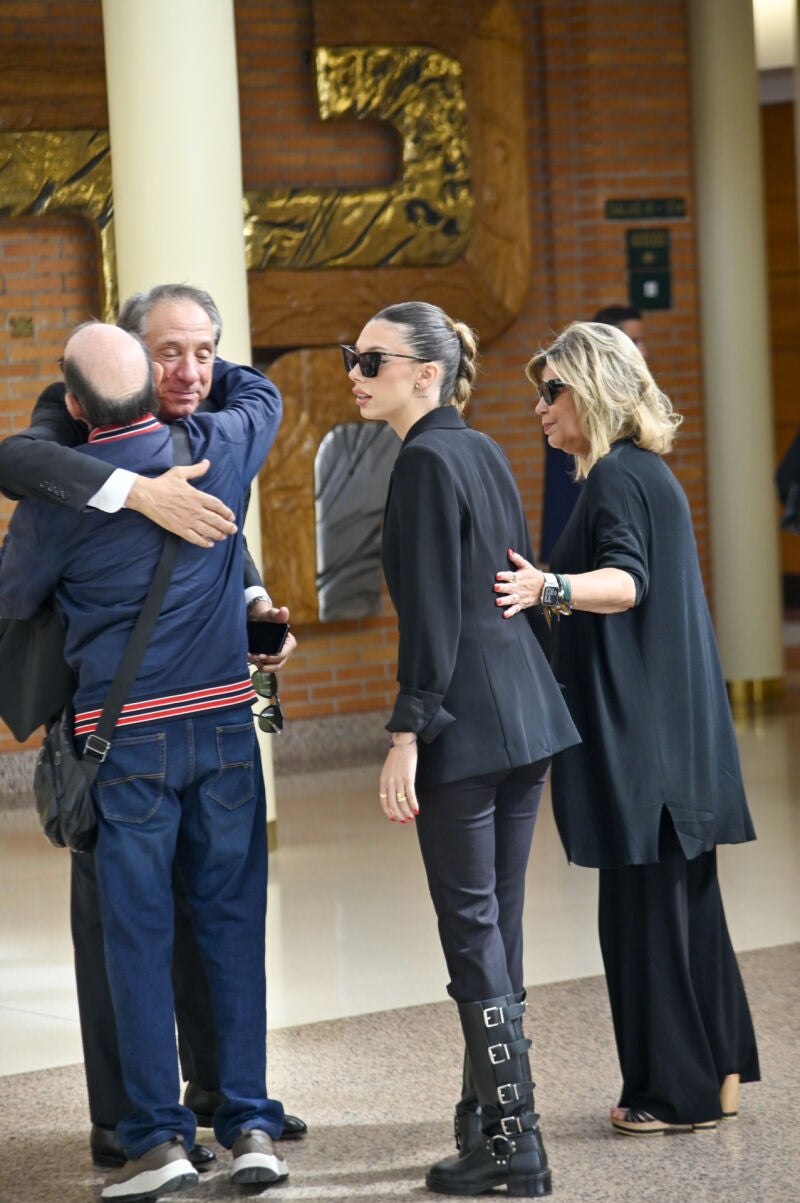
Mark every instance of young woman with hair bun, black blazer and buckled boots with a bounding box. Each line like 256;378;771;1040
343;302;577;1196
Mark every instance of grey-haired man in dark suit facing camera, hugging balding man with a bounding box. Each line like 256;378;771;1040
0;285;306;1167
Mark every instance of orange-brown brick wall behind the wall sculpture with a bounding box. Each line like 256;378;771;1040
0;0;709;748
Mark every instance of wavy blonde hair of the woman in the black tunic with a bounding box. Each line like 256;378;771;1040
525;321;683;480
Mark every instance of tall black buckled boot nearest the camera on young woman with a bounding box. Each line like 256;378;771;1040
425;991;552;1198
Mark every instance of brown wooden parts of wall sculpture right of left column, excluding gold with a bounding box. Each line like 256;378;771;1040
250;0;531;623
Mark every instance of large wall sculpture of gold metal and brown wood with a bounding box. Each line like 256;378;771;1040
0;0;531;621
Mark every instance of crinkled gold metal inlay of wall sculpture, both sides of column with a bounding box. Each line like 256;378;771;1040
0;39;473;327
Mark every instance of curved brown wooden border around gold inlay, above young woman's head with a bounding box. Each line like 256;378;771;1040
249;0;531;348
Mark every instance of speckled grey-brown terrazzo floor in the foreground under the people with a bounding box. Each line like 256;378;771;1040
0;944;800;1203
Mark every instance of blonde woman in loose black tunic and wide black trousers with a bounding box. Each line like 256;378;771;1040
496;322;759;1136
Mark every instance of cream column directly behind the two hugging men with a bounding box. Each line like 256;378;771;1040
102;0;275;843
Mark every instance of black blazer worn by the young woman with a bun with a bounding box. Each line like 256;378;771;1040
383;405;579;786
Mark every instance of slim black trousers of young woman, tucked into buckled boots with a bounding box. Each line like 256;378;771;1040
415;760;550;1002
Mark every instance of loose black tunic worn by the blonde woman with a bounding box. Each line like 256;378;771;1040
552;439;755;869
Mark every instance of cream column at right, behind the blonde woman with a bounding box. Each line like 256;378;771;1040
687;0;783;701
